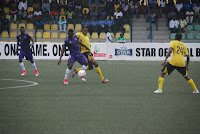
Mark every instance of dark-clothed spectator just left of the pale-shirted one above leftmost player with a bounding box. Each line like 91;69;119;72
8;1;18;23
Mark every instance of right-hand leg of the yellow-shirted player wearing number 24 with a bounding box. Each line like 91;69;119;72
177;67;199;94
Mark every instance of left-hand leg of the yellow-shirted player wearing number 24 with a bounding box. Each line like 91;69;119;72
154;63;174;93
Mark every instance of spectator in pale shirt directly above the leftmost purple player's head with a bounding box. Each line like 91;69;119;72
18;0;27;22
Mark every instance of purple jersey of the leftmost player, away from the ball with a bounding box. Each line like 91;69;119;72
17;33;32;52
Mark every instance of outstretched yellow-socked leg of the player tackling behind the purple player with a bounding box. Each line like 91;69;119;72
90;56;109;83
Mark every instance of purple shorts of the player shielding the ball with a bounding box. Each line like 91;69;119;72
68;53;88;65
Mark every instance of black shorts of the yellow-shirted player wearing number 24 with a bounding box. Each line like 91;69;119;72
161;62;188;77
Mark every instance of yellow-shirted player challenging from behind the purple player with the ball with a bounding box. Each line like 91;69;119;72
72;27;109;83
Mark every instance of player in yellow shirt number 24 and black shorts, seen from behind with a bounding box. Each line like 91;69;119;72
154;33;199;94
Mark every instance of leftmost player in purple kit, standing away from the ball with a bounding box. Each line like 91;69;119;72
16;27;39;76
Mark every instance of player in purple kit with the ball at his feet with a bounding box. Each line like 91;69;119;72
58;29;89;84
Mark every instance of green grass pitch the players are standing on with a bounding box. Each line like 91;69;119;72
0;60;200;134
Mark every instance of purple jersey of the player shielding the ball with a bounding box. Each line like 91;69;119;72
63;35;81;54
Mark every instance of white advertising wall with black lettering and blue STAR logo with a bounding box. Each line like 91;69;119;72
0;42;200;62
